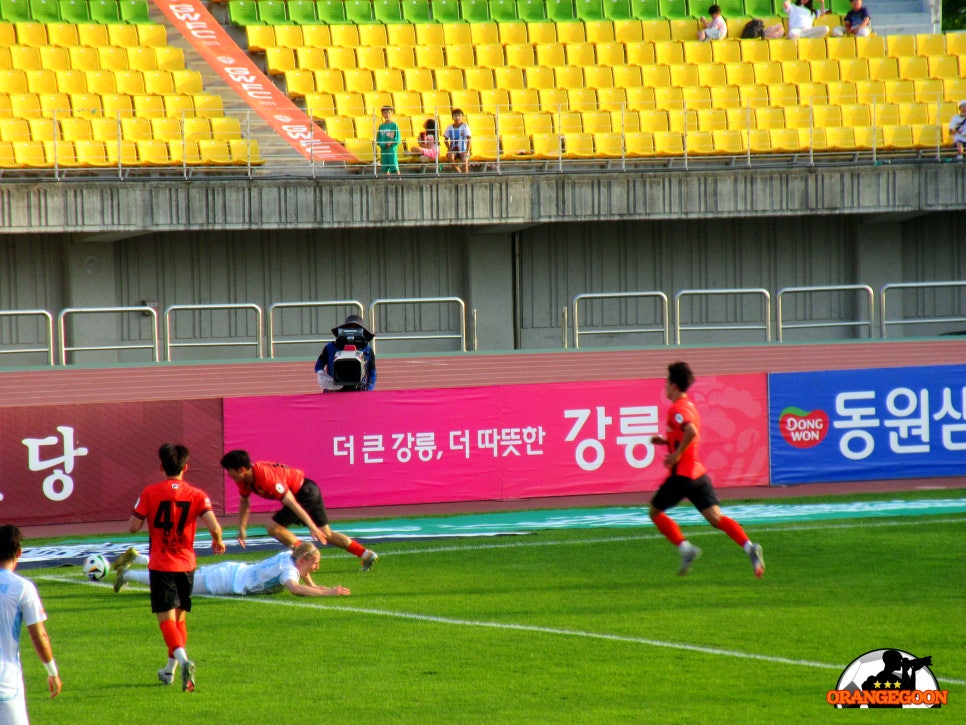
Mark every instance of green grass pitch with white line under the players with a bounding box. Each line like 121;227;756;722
22;498;966;725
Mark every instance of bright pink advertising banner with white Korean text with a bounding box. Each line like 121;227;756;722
224;374;768;513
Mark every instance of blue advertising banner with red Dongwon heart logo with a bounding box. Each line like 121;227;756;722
768;365;966;484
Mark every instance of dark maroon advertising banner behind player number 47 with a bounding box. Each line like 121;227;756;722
0;399;224;530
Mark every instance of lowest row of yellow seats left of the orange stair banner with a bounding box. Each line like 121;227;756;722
0;139;262;169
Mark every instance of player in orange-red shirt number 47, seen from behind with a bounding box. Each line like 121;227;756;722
128;443;225;692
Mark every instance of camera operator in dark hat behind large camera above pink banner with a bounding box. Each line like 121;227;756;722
315;315;376;392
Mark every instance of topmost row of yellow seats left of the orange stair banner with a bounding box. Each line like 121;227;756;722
0;23;168;48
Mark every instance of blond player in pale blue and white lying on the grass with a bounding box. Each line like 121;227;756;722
111;542;350;597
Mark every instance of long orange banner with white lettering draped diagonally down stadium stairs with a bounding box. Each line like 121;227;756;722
154;0;357;161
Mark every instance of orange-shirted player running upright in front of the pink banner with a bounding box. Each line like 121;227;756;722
650;362;765;578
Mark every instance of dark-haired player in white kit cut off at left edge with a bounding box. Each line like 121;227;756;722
0;524;61;725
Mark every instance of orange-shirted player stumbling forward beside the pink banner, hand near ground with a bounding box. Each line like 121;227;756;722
221;450;379;571
